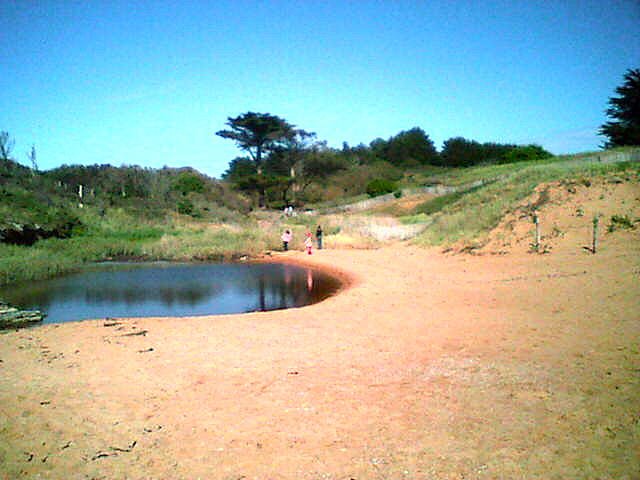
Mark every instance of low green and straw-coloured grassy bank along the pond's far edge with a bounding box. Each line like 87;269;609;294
0;210;277;284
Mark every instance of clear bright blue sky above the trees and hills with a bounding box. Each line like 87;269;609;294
0;0;640;177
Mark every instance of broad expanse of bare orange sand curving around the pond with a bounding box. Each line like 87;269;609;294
0;181;640;479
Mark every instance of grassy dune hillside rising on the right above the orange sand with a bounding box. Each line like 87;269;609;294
292;149;640;251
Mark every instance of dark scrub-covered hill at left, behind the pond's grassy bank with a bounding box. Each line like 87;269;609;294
0;160;250;245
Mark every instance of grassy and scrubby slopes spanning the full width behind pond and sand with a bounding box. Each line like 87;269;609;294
0;149;639;283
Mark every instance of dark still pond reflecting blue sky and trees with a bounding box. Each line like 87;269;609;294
0;263;340;323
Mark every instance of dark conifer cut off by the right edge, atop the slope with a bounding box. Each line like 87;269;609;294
599;69;640;148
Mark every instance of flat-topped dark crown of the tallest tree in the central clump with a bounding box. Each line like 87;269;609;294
216;112;293;174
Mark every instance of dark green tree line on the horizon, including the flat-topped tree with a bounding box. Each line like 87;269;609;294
217;112;551;207
